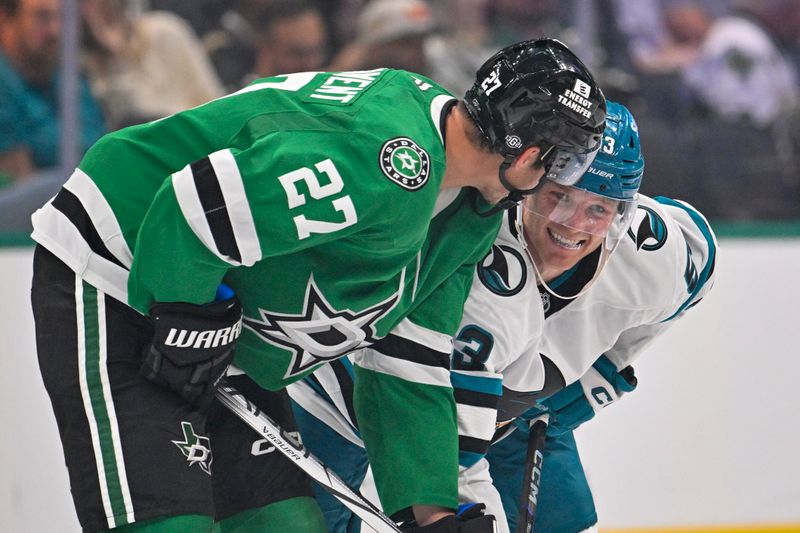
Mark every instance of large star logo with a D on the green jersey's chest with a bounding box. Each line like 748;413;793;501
243;276;398;378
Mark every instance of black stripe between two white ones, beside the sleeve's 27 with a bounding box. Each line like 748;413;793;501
190;157;242;263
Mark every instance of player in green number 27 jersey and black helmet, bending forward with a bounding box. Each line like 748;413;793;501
32;39;605;533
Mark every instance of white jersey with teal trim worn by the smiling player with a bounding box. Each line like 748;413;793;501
451;195;717;466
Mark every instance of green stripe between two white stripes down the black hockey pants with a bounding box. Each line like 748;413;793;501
83;282;128;527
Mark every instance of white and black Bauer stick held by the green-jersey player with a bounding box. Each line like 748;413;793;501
217;383;401;533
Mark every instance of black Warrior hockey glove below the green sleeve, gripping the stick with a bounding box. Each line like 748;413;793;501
142;296;242;406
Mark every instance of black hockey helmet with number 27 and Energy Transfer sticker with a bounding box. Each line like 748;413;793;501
464;39;606;187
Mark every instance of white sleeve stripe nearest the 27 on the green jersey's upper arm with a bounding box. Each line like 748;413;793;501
208;150;261;266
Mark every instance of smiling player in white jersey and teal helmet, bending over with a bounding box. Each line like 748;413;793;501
290;103;717;533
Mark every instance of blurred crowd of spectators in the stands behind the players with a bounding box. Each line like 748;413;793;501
0;0;800;232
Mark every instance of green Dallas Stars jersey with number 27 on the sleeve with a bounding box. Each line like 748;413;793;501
33;69;500;512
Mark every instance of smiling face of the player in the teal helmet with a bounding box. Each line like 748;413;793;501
523;181;620;281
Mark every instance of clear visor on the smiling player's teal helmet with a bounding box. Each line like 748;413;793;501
522;181;637;244
